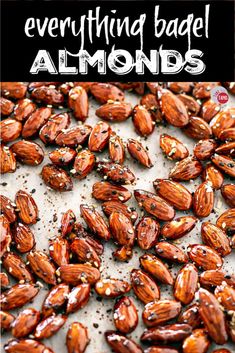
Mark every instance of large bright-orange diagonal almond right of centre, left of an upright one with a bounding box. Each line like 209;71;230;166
153;179;193;211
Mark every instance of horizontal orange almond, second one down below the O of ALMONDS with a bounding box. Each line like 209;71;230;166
96;101;132;122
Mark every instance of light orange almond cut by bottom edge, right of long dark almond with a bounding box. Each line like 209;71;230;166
182;329;210;353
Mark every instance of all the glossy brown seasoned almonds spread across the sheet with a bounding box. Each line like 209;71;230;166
0;82;235;353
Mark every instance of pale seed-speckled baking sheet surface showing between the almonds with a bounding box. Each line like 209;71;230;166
0;92;235;353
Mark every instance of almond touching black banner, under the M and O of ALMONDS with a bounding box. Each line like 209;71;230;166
90;82;124;104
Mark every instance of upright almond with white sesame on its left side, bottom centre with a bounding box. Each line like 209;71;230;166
113;297;138;334
